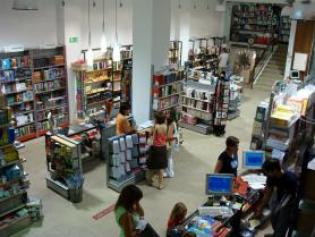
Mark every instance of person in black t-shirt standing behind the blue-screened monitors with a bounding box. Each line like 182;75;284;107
214;136;240;177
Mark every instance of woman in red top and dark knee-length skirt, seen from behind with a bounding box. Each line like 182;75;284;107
147;112;168;189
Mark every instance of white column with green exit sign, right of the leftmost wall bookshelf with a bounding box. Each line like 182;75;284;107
57;0;82;122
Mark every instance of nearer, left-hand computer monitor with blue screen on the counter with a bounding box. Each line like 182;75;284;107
206;174;234;196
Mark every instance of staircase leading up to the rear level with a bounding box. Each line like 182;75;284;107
254;45;288;91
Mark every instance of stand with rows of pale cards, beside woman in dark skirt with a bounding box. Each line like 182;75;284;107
107;134;149;192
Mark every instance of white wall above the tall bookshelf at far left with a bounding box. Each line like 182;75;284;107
0;0;57;48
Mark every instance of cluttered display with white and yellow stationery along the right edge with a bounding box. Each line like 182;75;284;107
250;82;315;170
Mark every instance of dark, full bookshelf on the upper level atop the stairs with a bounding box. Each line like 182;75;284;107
230;3;281;46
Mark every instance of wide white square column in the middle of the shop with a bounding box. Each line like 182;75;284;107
132;0;171;124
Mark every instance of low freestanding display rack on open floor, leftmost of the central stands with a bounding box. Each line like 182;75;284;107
46;134;84;203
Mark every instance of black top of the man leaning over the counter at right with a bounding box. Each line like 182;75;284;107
267;171;298;201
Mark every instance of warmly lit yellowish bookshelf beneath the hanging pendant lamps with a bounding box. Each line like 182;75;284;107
72;58;113;118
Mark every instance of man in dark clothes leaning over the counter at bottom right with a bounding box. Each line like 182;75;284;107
256;159;298;237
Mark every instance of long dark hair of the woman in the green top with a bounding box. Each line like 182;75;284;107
115;185;143;212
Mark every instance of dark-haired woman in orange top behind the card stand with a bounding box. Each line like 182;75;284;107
116;103;135;135
